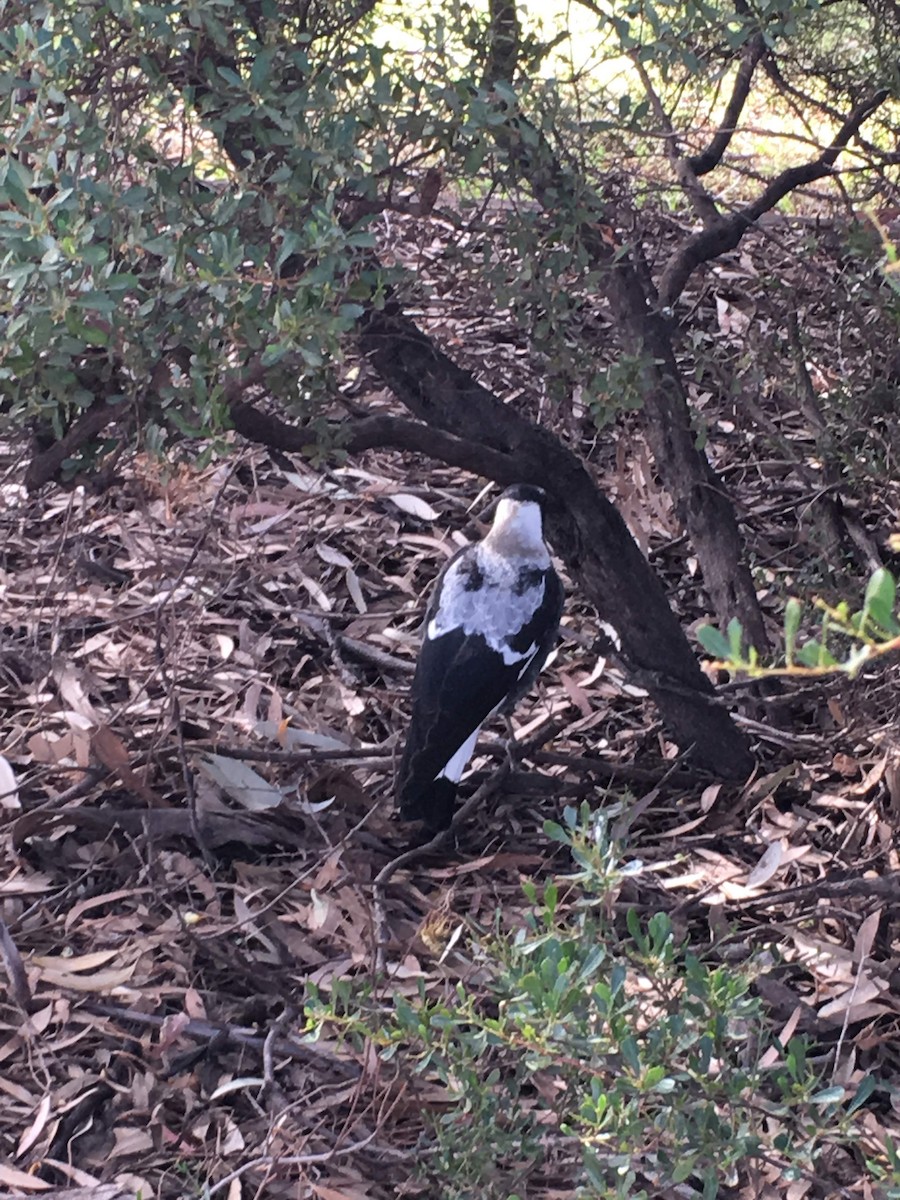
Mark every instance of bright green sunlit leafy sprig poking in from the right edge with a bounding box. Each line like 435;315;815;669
697;568;900;679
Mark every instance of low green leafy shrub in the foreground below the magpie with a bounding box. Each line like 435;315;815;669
307;808;900;1200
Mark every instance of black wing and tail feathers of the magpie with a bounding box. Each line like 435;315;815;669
397;547;563;828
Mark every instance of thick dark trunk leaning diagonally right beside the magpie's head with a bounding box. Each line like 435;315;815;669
361;302;752;779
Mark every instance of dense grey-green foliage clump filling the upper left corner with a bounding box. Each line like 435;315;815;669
0;0;392;460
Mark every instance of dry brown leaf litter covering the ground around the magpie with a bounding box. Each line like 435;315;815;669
0;208;900;1200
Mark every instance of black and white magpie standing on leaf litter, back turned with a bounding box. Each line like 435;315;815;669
397;484;563;829
